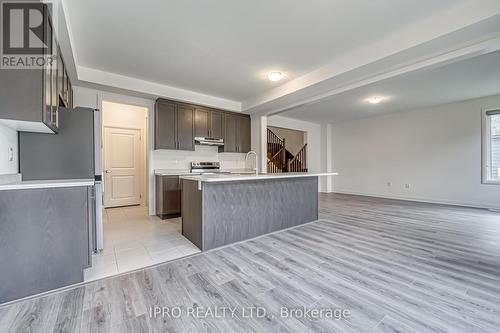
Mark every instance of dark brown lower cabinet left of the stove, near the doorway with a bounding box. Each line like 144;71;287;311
156;175;181;220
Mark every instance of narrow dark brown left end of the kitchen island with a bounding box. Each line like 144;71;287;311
181;179;203;250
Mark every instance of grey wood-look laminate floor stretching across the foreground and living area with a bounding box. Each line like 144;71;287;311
0;194;500;333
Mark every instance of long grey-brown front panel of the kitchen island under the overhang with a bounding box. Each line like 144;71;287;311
203;177;318;250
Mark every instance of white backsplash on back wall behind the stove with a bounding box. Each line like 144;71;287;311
151;146;246;170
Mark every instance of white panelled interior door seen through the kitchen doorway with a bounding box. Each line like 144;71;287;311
104;127;141;207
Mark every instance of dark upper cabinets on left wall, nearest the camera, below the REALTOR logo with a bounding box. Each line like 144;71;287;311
0;5;73;133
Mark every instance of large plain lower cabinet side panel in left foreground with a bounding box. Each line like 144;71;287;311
0;186;93;303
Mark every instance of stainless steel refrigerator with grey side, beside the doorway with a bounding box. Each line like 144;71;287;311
19;108;103;251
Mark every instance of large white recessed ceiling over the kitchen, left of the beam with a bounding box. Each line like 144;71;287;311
65;0;464;102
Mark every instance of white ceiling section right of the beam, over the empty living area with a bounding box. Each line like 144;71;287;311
281;51;500;123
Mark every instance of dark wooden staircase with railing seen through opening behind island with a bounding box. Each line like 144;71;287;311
267;128;307;173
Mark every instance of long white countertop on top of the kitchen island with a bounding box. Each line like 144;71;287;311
180;172;338;183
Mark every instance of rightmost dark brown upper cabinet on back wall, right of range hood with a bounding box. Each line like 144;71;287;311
224;113;251;153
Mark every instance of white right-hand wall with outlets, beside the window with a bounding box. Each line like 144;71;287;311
332;95;500;208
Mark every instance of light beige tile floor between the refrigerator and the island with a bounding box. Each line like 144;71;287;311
85;206;200;281
